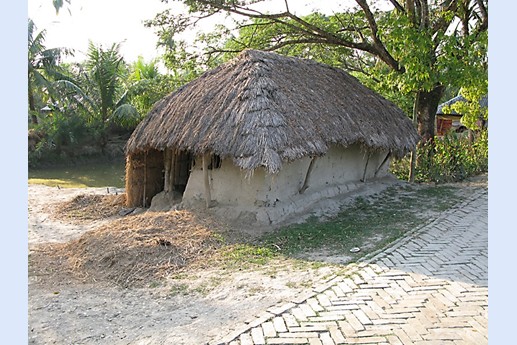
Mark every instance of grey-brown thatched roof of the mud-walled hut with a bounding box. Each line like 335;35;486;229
126;50;418;173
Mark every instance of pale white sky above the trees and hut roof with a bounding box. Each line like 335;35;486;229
28;0;356;62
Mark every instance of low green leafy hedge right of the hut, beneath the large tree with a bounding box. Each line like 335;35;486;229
390;130;488;183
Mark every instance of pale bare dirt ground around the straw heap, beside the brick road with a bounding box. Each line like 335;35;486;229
28;185;342;344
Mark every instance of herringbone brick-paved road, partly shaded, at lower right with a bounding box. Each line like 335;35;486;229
215;189;488;345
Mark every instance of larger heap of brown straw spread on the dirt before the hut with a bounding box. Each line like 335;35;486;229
29;210;222;287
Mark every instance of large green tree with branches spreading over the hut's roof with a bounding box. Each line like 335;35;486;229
148;0;488;140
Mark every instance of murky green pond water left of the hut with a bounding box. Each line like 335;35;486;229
29;161;125;188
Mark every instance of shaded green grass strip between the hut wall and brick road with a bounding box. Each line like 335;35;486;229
220;186;460;268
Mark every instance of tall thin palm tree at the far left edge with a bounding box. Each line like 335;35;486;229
27;19;71;125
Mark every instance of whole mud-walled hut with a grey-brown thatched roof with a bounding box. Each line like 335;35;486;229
126;50;418;221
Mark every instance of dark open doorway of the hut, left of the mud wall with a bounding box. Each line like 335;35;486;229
164;151;195;196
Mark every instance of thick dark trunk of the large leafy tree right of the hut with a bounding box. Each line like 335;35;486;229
415;85;445;142
